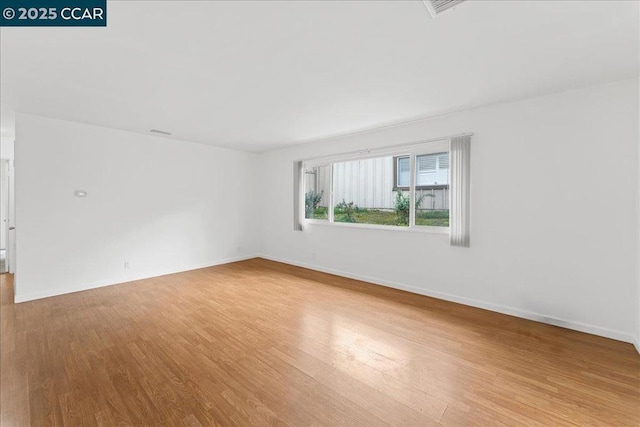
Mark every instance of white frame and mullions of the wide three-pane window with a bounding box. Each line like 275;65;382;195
302;139;451;234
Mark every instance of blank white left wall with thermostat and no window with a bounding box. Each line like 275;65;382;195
15;114;259;301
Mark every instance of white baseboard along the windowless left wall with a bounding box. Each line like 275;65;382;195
14;255;259;304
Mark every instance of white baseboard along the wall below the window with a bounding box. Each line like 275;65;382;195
260;255;640;346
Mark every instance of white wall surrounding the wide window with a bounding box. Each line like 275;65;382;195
261;79;639;342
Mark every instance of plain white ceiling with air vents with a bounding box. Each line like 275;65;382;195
0;1;639;151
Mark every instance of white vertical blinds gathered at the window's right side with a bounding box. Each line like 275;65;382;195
450;136;471;248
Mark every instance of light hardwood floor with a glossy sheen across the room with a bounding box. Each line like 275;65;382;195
0;259;640;427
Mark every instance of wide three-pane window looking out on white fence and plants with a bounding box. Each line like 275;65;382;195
304;141;450;231
